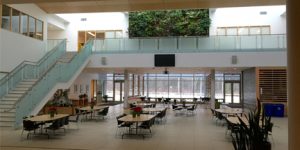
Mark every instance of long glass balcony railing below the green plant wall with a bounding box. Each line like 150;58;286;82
93;34;286;53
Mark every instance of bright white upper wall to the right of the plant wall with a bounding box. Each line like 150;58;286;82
210;6;286;35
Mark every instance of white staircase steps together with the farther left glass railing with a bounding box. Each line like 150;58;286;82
0;40;66;127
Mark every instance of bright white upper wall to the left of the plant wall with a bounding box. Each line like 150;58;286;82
58;12;128;51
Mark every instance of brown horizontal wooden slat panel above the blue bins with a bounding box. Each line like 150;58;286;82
258;68;287;102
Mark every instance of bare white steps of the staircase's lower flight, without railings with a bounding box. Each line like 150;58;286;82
0;79;37;127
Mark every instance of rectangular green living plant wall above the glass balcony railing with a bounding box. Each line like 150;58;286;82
128;9;210;37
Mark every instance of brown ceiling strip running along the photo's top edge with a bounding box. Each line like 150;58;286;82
2;0;286;13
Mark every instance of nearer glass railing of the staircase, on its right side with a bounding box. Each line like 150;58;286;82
13;40;93;127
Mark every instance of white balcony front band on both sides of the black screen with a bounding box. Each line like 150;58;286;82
87;52;287;68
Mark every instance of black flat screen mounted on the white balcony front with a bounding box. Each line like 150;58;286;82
154;54;175;67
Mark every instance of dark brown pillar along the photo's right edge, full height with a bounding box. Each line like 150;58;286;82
287;0;300;150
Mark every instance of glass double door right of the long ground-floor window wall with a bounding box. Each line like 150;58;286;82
224;82;241;103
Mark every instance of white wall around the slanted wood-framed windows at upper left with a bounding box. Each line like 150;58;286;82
0;4;68;72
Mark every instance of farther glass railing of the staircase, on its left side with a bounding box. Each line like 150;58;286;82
0;40;66;97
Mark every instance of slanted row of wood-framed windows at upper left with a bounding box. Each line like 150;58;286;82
1;5;44;40
